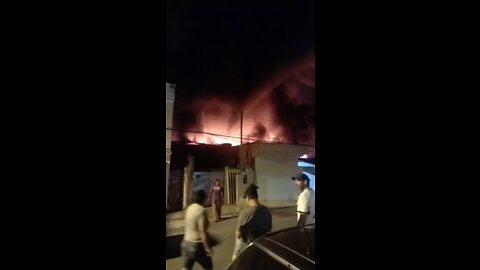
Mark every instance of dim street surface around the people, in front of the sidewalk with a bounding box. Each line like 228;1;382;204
167;207;296;270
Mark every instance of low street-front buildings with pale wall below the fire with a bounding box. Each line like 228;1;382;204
167;139;315;212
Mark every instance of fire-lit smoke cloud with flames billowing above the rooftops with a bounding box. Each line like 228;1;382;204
173;49;315;145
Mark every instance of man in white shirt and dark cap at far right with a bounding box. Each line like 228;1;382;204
292;173;315;226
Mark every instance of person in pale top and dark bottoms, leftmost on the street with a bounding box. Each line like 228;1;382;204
182;190;213;270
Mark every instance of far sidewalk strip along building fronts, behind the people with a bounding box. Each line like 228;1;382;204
166;200;296;236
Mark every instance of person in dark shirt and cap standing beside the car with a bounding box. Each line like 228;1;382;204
232;184;272;261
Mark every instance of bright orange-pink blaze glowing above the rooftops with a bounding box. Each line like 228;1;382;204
173;50;315;148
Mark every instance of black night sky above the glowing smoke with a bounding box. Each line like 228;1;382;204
166;0;315;146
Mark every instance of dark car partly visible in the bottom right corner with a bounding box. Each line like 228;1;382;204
226;224;315;270
